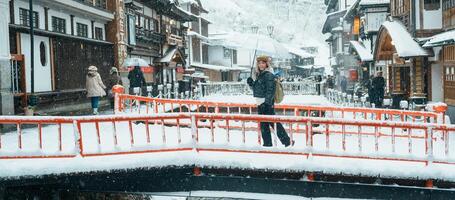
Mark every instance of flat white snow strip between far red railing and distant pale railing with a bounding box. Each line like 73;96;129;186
201;94;333;105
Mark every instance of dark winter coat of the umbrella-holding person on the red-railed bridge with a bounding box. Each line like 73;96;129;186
250;71;275;106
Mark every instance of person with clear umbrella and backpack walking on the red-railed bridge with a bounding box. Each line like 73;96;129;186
247;56;294;147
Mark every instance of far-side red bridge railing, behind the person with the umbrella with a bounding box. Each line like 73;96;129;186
115;94;444;123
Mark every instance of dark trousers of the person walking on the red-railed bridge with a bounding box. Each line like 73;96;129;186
258;104;291;147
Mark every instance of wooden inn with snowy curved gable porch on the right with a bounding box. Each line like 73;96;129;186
374;0;442;108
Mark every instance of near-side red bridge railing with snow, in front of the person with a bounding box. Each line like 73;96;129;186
0;113;455;164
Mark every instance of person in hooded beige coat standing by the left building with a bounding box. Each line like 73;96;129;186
85;66;106;115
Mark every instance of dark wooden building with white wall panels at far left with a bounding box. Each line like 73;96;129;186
8;0;115;112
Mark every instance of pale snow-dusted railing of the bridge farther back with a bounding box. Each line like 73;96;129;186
197;81;318;97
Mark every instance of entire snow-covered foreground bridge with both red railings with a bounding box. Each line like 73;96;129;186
0;95;455;198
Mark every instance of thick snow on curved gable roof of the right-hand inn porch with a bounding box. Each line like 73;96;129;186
379;20;430;58
